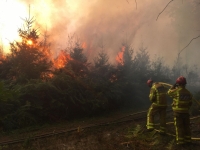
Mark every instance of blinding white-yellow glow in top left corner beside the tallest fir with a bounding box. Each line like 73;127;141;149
0;0;28;53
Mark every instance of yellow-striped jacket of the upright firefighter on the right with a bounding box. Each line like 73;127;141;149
167;86;192;113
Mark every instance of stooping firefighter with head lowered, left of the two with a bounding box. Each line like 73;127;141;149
146;79;167;134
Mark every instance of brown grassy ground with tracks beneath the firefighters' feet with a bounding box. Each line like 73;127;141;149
0;109;200;150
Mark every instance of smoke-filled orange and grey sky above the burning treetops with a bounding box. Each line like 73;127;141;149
0;0;200;65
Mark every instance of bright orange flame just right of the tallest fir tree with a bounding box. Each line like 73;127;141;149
53;50;72;69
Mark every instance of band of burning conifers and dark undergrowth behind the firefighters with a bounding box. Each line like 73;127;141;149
0;15;200;131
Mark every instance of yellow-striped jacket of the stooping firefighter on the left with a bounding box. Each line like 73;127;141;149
149;82;167;106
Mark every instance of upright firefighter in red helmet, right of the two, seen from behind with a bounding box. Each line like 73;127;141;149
167;76;192;144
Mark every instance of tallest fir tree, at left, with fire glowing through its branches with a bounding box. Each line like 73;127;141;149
0;19;51;83
